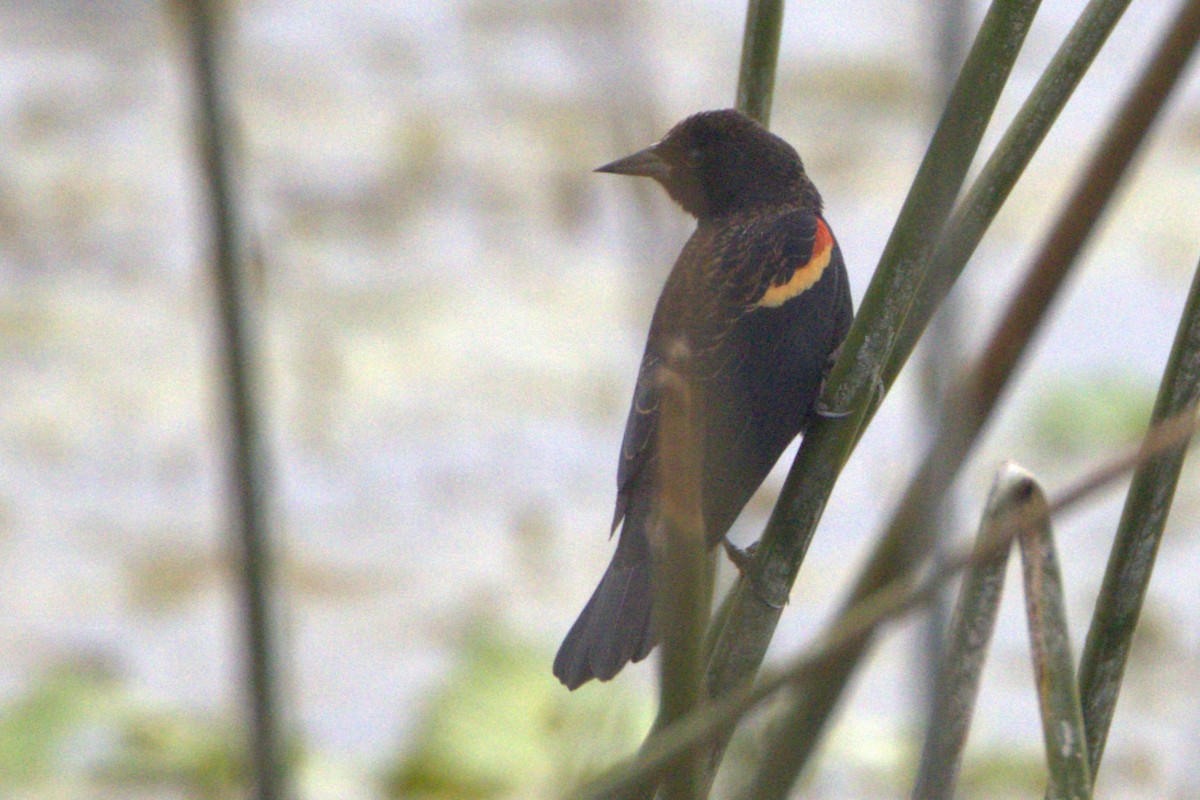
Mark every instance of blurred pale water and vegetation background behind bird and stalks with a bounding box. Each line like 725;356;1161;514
0;0;1200;799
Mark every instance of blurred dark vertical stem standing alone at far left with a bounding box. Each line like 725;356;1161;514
182;0;286;800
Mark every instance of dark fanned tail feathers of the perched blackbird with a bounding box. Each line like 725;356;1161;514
554;515;656;690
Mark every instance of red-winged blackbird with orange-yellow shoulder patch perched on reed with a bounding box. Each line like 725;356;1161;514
554;110;853;688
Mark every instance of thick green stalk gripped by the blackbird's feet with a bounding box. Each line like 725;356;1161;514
708;0;1038;767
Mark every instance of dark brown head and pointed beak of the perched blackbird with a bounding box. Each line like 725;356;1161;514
596;109;821;219
